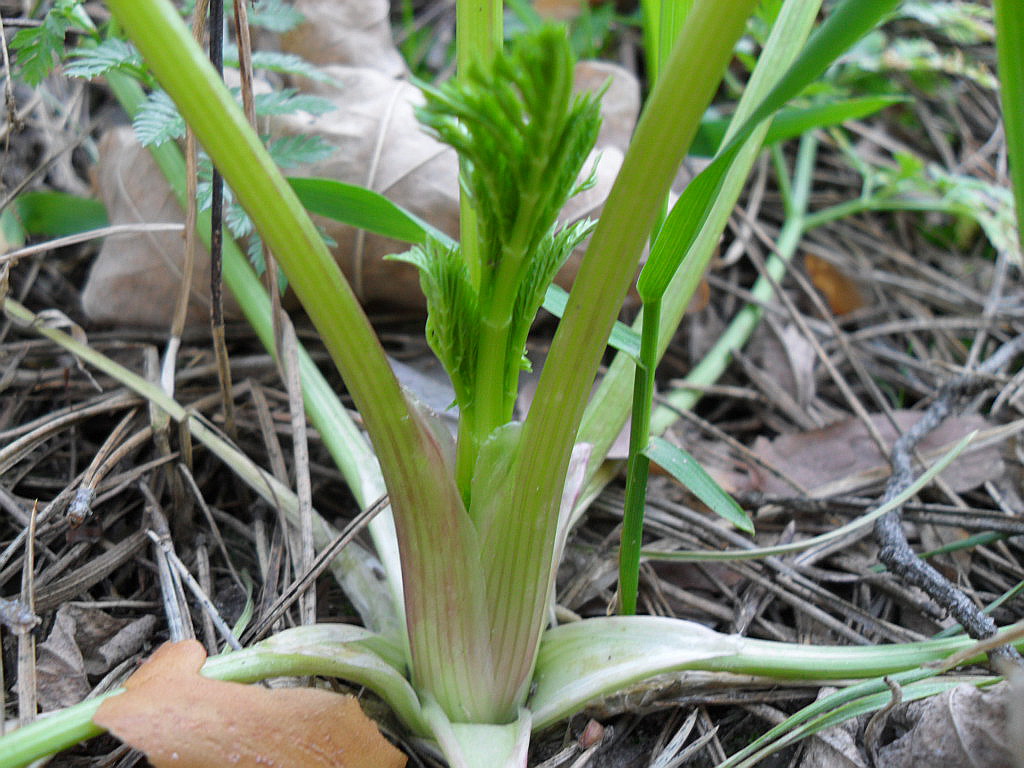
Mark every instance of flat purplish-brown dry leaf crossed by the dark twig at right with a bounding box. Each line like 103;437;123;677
744;411;1004;496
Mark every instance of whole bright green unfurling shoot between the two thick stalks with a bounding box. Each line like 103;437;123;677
396;28;600;442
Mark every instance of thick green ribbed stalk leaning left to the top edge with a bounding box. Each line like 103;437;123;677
110;0;507;722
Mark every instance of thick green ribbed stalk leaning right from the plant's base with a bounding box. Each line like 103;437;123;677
484;0;756;716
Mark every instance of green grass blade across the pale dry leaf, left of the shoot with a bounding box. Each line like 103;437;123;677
288;177;455;247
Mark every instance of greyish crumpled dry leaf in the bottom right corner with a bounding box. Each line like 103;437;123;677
878;683;1012;768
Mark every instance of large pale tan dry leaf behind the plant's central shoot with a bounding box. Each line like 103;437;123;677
82;56;639;327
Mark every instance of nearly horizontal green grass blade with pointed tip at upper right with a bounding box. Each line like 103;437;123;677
690;96;907;158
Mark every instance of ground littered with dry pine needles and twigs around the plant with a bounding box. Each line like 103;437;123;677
0;3;1024;768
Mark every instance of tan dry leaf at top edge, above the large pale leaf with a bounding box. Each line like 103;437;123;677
281;0;407;77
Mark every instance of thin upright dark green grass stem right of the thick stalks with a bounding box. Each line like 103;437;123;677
618;299;662;615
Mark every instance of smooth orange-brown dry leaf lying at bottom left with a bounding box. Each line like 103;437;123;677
92;640;406;768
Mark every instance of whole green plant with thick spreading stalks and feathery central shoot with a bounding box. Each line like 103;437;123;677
8;0;1024;768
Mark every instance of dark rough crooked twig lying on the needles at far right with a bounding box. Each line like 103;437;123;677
874;335;1024;663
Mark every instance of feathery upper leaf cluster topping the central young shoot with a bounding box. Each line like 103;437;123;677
417;28;599;290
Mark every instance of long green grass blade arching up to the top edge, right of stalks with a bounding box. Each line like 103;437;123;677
637;0;898;301
